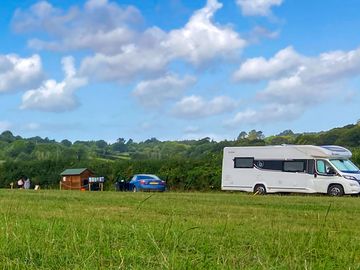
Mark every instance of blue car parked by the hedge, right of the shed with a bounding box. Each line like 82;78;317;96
129;174;166;192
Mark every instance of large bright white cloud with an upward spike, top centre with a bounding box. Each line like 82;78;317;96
81;0;246;81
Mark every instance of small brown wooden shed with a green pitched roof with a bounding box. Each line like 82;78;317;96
60;168;94;190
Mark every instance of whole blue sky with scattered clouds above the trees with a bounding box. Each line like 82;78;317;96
0;0;360;142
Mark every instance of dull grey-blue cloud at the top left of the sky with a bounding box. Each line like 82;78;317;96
13;0;142;53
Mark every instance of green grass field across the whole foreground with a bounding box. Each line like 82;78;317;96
0;190;360;269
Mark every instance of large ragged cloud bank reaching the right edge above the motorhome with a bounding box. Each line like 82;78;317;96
227;48;360;126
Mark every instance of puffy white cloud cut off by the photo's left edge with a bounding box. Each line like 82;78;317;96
0;54;43;93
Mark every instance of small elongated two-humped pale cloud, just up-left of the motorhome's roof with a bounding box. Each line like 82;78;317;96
173;96;238;119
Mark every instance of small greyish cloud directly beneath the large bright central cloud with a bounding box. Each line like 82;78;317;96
133;74;196;108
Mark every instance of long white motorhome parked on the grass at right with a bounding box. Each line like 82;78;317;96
221;145;360;196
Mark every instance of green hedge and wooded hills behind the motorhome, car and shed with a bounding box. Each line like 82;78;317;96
0;124;360;190
